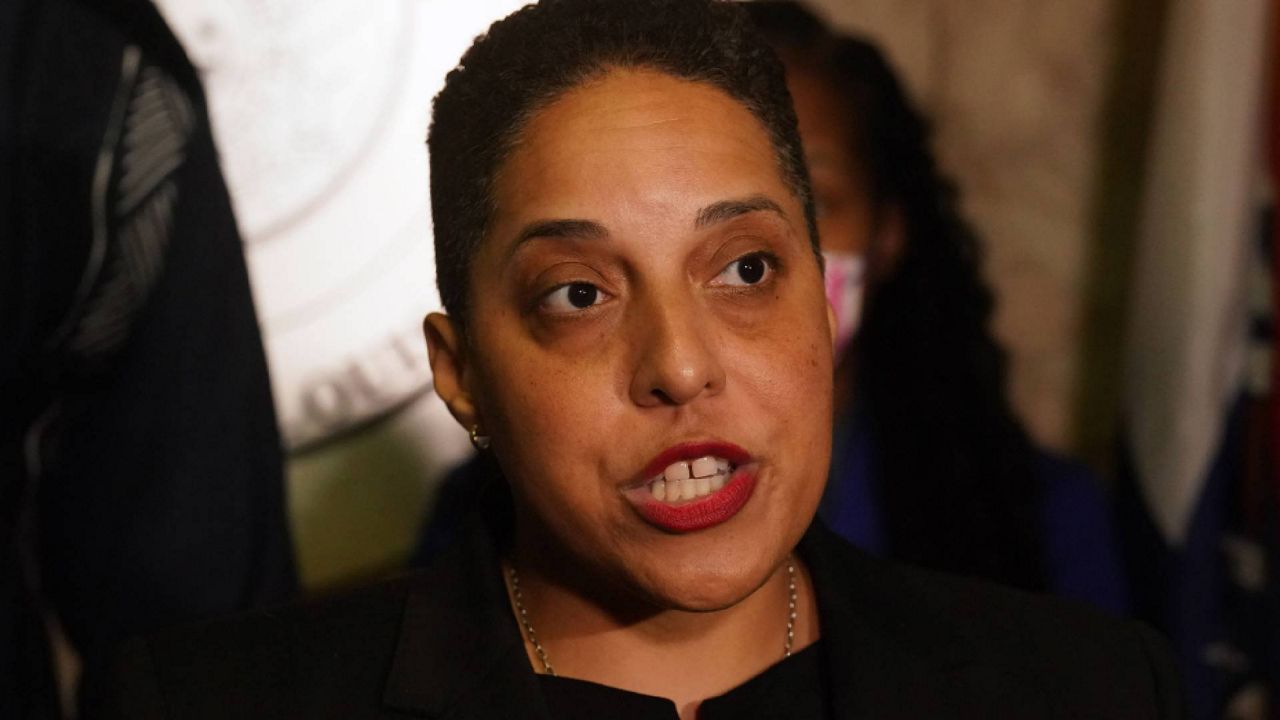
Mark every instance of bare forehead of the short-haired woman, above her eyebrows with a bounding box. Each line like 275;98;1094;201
494;69;790;227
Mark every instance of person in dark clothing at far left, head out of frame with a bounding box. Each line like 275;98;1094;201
0;0;296;719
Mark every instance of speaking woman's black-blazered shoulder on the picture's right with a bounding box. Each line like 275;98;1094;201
805;520;1183;717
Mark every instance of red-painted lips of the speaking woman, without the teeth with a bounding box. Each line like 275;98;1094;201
626;442;758;533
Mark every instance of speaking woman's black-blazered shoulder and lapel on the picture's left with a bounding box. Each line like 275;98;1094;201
108;515;524;720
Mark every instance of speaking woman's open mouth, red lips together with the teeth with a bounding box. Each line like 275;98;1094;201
623;442;758;533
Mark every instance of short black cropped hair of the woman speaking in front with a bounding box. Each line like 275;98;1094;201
428;0;818;328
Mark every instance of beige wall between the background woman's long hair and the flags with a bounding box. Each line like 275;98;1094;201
814;0;1115;450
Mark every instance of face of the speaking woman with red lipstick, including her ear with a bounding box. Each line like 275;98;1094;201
429;70;832;610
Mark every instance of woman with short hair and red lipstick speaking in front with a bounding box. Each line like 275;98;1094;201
110;0;1178;719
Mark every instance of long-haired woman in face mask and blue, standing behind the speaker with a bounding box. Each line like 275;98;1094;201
744;1;1128;612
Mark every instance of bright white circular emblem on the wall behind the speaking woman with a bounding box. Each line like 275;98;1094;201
157;0;535;451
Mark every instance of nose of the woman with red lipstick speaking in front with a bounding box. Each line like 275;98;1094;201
631;289;724;407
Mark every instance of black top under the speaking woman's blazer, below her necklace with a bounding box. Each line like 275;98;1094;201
538;641;831;720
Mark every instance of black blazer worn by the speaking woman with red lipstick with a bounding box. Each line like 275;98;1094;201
104;515;1183;720
